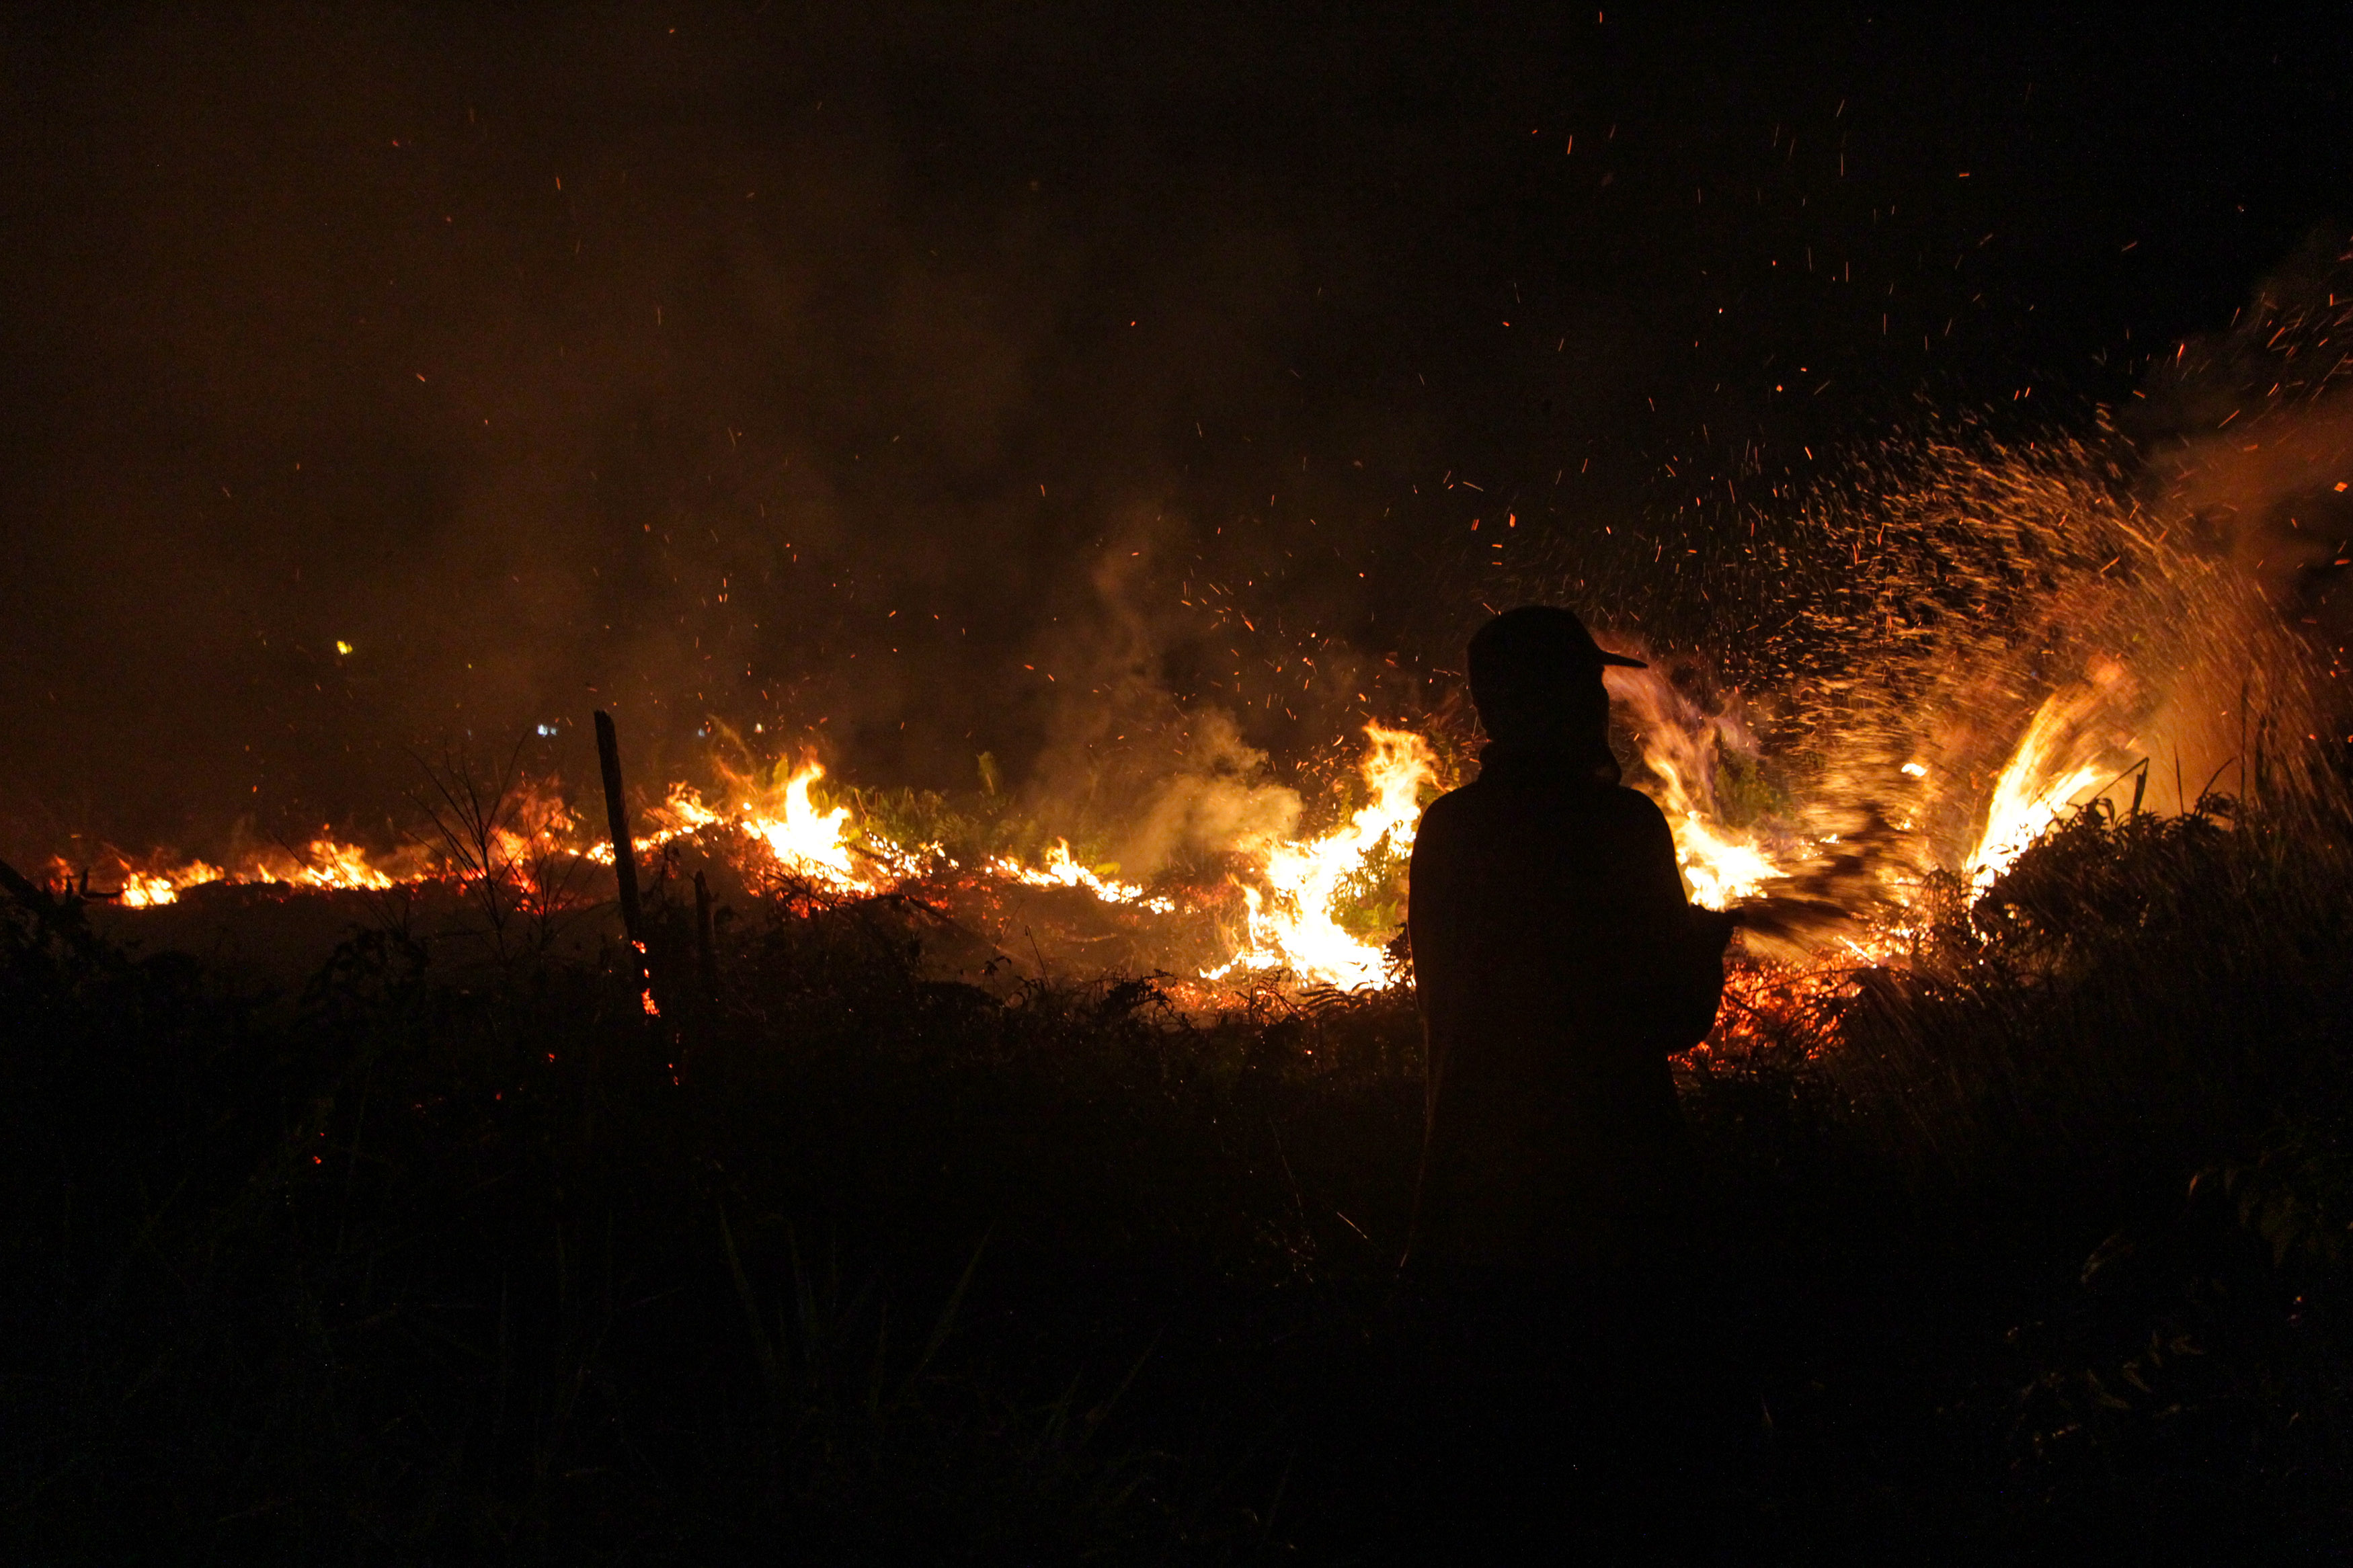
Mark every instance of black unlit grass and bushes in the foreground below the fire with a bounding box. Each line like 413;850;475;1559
0;804;2353;1563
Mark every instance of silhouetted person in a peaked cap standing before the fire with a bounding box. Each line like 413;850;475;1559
1410;606;1732;1298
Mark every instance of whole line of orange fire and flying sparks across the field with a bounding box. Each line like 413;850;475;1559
52;413;2342;1067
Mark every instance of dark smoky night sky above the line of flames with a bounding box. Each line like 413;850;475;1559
0;2;2353;854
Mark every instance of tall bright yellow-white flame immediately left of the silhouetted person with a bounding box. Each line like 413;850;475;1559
1203;724;1435;990
